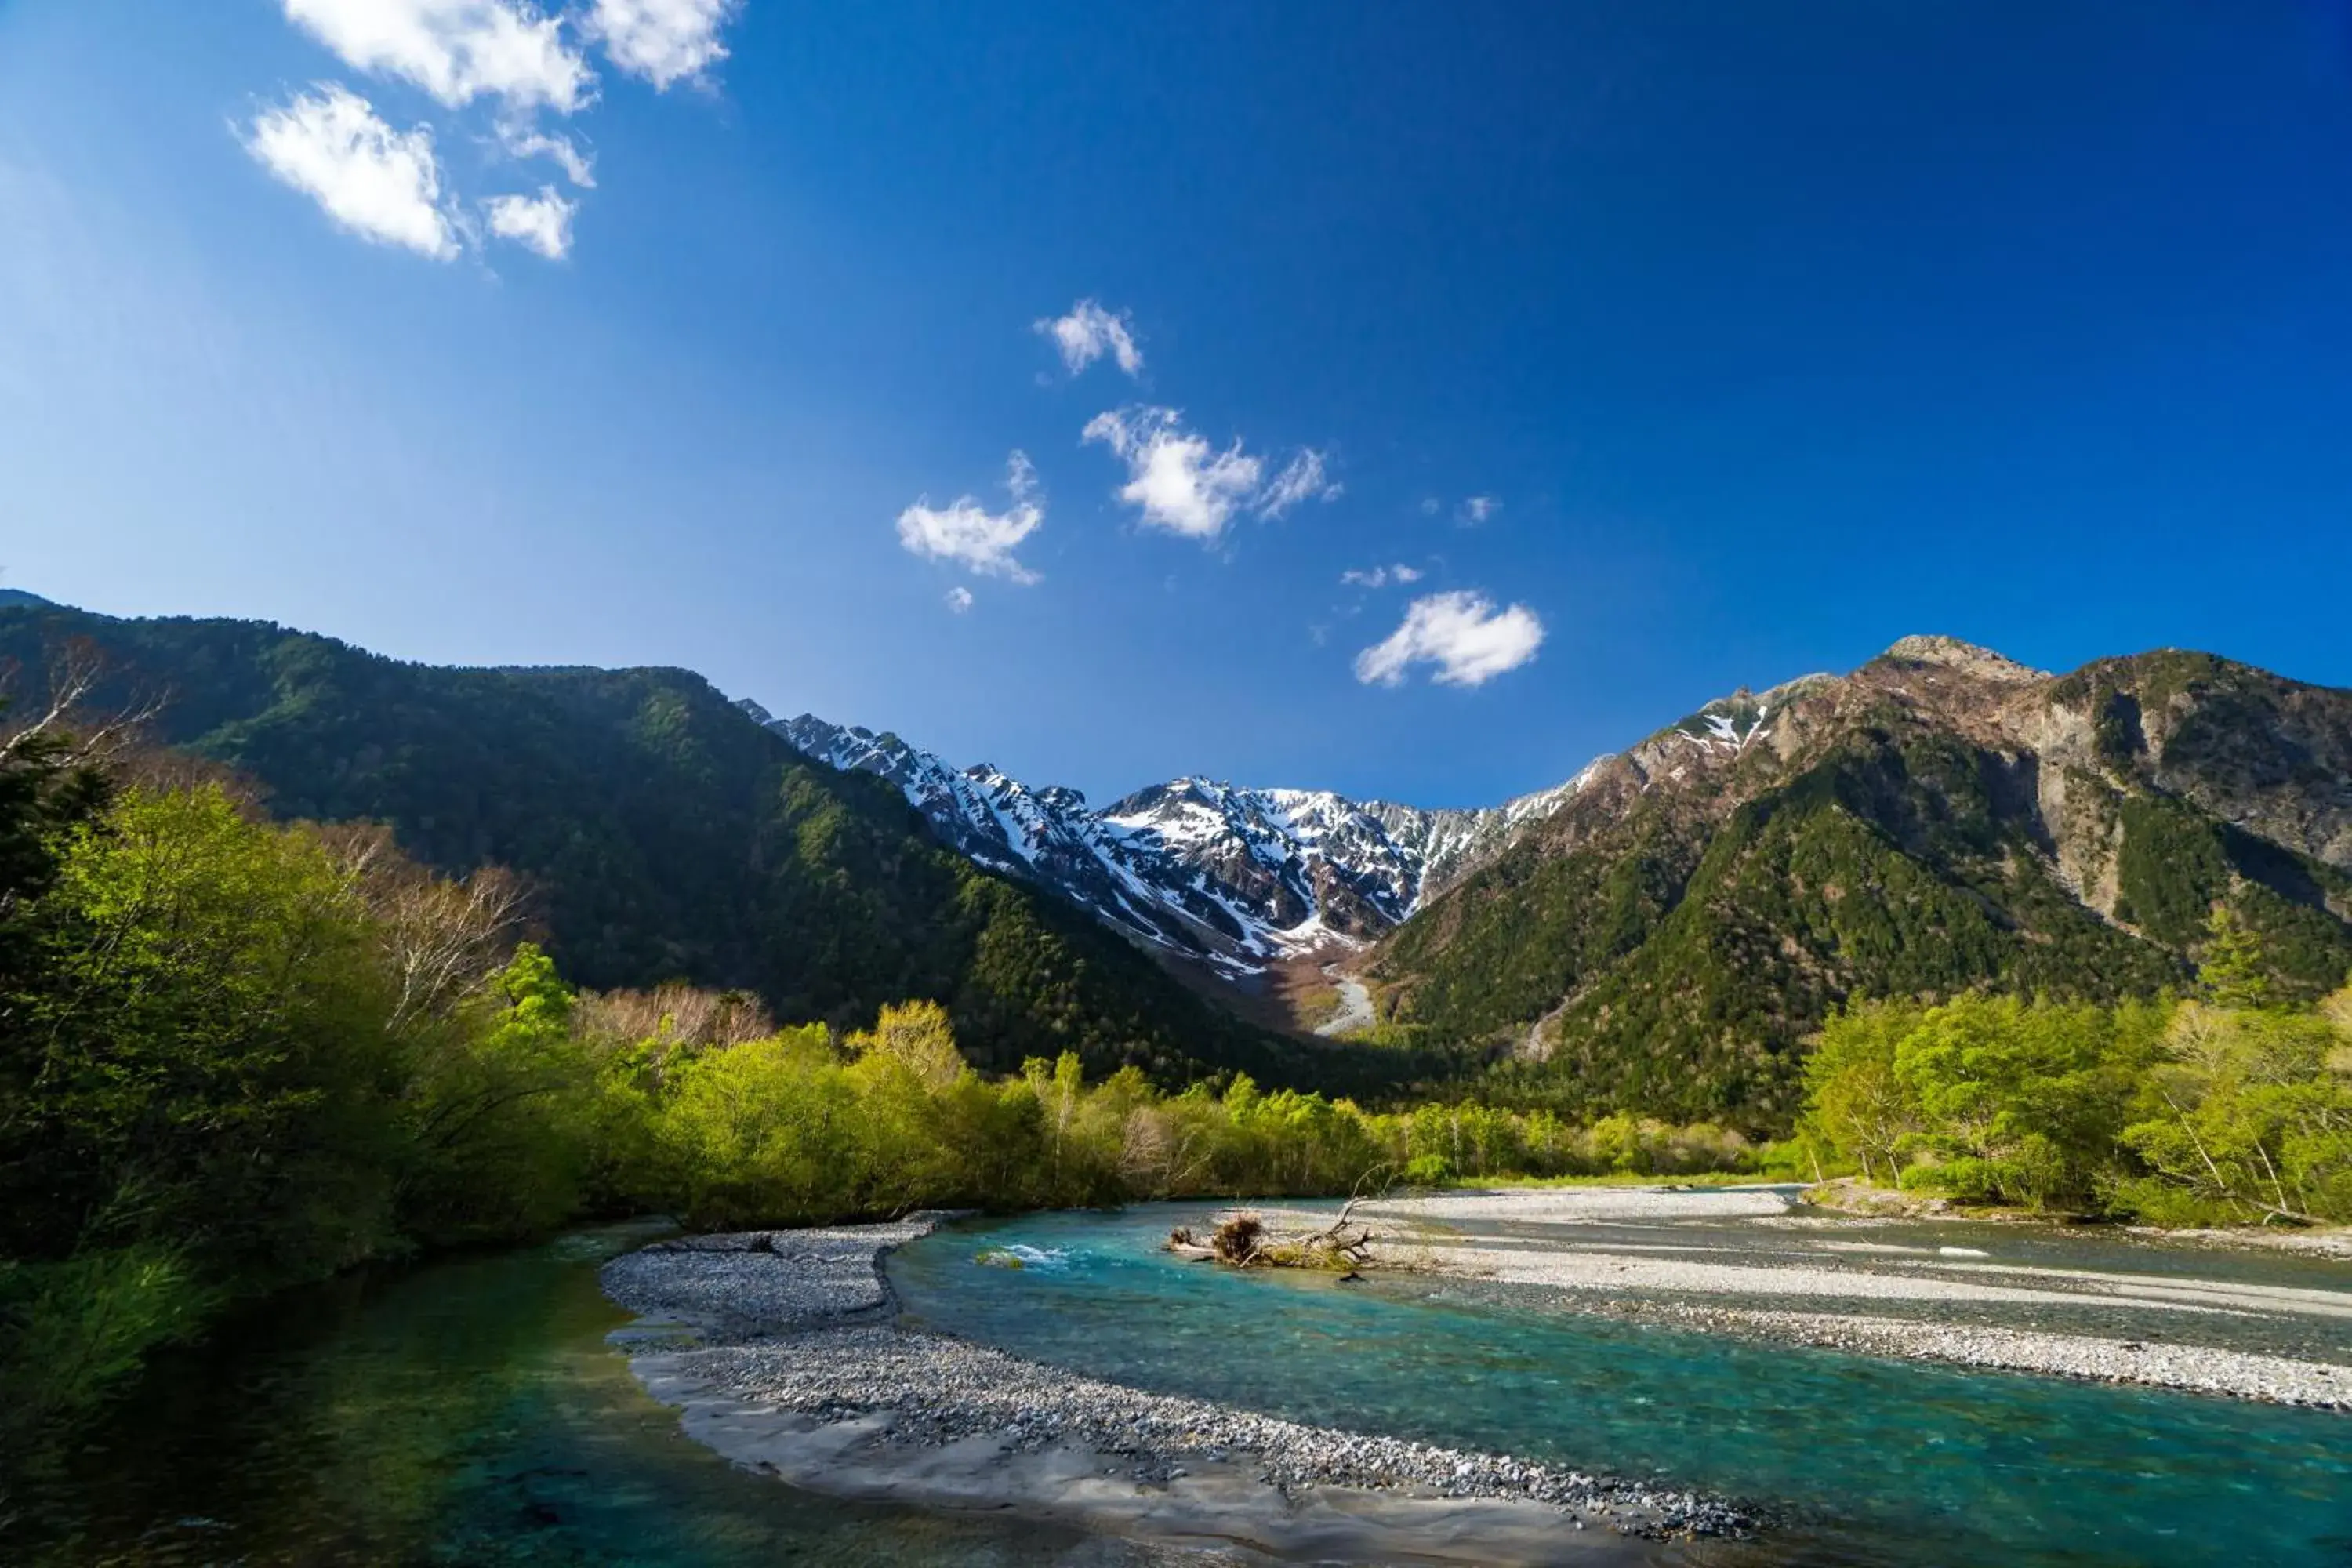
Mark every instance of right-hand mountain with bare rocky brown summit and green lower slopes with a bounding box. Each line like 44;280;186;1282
1369;637;2352;1128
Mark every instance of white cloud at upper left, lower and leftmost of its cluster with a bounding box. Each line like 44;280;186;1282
245;82;459;261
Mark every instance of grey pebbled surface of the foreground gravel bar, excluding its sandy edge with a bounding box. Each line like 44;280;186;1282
602;1215;1755;1561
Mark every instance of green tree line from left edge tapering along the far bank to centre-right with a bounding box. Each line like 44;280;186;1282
0;691;1748;1450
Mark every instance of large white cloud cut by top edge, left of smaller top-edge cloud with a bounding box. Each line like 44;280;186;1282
285;0;595;115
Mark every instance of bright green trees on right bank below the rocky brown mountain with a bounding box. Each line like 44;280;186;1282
1799;909;2352;1227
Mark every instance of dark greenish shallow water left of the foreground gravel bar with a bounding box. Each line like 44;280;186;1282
0;1232;1157;1568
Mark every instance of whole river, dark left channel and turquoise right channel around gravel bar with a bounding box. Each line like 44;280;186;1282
18;1208;2352;1568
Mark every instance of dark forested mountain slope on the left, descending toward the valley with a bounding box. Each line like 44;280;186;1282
0;604;1364;1083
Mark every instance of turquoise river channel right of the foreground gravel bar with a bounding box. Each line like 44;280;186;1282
889;1206;2352;1568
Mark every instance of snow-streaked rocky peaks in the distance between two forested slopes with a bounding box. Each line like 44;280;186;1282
743;703;1583;978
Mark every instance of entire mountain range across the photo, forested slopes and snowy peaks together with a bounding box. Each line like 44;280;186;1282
0;602;2352;1133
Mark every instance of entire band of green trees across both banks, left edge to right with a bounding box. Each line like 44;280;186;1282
0;681;2352;1453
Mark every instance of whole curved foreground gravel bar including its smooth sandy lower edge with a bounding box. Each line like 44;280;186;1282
602;1218;1750;1563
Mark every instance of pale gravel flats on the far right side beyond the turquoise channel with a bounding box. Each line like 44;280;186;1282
1289;1187;2352;1410
